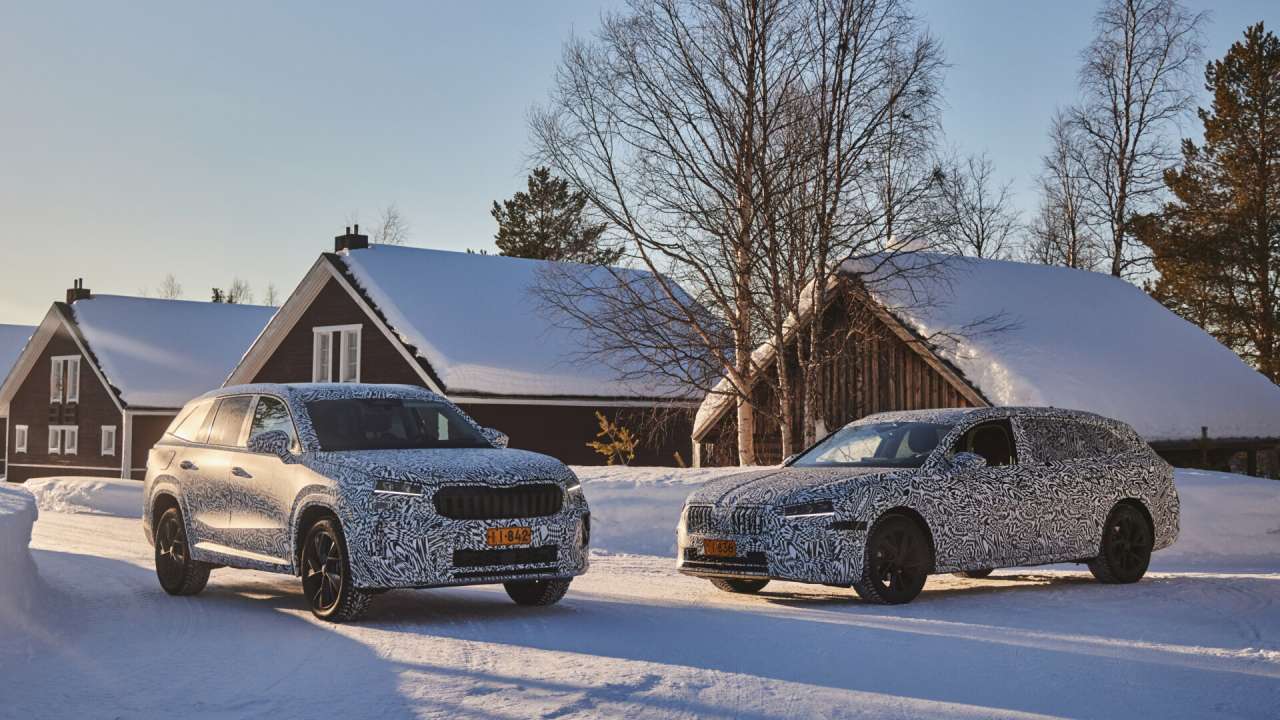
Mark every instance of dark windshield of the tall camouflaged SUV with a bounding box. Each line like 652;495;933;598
307;397;492;450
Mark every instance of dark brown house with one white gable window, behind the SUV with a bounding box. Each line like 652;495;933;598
227;225;698;465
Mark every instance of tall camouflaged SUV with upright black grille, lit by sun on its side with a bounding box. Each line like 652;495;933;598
142;384;590;620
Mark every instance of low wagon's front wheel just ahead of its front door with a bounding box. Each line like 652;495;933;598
854;512;933;605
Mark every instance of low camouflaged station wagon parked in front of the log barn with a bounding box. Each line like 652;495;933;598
677;407;1178;603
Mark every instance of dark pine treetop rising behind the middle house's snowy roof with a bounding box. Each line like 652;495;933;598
490;168;622;265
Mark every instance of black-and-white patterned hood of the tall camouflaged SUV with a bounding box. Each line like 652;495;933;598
305;447;573;486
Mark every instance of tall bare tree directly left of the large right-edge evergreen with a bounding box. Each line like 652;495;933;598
1073;0;1206;277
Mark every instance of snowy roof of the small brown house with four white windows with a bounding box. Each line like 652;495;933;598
70;295;275;407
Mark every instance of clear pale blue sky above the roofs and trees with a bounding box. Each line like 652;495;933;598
0;0;1280;324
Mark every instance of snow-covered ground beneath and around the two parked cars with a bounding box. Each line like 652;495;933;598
0;469;1280;719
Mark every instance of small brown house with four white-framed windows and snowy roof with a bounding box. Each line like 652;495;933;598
0;281;274;482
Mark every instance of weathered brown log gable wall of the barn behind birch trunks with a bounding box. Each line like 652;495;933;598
701;297;973;466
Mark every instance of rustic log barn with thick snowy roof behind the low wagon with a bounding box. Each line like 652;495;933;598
694;254;1280;474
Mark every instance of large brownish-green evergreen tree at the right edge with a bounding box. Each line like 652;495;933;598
1135;23;1280;382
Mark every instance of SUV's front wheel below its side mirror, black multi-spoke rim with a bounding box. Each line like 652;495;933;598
298;518;372;623
